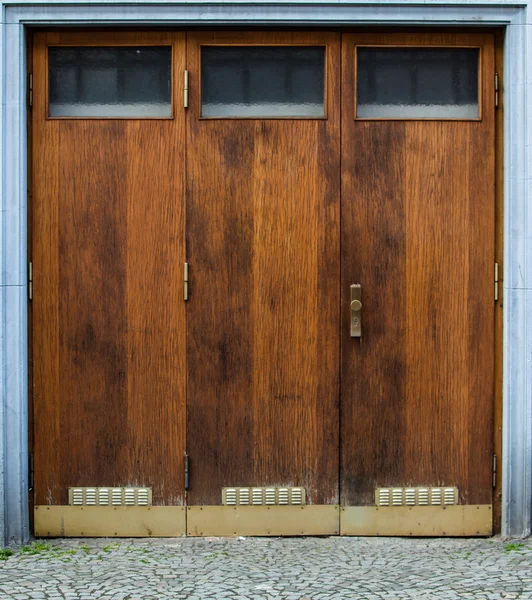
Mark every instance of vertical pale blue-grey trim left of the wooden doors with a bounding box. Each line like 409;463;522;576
1;18;29;543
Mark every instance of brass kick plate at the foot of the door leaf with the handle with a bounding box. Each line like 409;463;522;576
340;504;493;537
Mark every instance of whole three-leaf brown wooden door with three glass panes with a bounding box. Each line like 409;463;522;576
31;32;495;534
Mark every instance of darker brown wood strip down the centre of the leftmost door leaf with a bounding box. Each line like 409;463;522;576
58;120;128;487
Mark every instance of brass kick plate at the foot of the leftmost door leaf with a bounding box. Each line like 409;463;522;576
34;505;186;537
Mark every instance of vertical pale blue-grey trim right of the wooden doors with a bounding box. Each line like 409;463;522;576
502;3;532;536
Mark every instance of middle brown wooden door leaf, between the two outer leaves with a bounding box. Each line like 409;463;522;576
187;32;340;505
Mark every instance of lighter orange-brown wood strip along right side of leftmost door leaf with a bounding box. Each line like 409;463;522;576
127;117;186;504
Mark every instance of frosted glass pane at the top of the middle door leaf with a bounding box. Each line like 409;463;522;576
201;46;325;117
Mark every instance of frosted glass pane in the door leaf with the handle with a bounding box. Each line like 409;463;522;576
356;48;479;119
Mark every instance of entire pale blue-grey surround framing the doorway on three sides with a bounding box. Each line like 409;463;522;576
0;0;532;542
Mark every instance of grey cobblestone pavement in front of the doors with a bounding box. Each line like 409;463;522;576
0;537;532;600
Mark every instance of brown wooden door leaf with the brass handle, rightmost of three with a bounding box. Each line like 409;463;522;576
341;34;495;506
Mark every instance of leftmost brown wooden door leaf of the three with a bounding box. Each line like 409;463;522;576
32;32;185;506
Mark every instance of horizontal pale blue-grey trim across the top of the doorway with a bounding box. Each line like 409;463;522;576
3;2;520;27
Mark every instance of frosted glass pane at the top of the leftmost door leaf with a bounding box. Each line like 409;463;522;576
48;46;172;118
